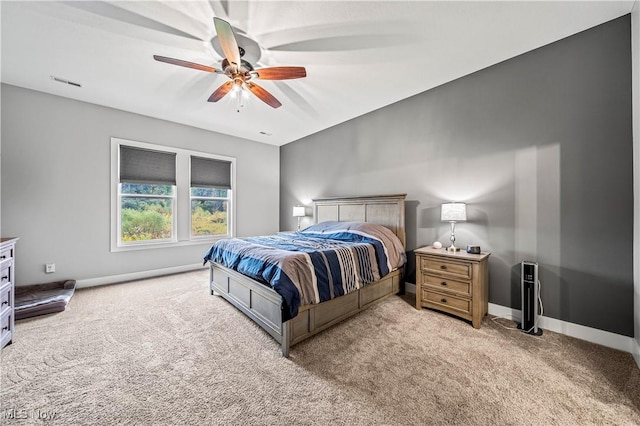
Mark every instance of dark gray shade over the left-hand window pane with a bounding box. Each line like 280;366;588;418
120;145;176;185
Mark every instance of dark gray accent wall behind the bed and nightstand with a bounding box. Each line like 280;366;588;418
280;16;634;336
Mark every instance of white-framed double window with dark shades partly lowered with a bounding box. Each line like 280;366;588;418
111;138;235;251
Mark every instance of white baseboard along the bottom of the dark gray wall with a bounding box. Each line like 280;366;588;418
405;283;640;358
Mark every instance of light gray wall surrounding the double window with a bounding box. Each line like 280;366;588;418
1;85;279;285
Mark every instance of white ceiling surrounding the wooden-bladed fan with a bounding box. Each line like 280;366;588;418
0;0;634;145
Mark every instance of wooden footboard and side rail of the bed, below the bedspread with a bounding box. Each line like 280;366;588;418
210;263;403;357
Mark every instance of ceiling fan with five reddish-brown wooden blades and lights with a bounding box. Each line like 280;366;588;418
153;18;307;108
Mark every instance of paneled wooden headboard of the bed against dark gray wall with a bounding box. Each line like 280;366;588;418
313;194;407;247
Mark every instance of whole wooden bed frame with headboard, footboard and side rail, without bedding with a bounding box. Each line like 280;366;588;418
210;194;406;357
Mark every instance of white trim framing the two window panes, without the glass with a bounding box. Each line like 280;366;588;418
110;137;237;252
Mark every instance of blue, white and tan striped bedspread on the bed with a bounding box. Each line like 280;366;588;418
204;222;406;321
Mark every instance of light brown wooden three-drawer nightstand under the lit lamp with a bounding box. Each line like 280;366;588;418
414;247;490;328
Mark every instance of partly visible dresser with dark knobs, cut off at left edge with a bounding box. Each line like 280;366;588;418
0;238;18;349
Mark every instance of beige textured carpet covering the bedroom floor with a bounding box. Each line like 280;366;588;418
0;271;640;425
